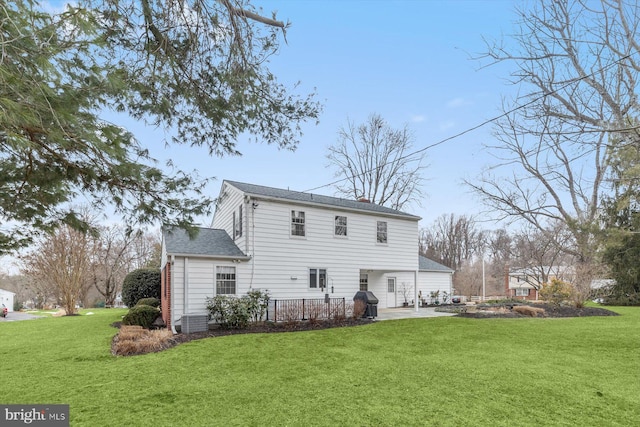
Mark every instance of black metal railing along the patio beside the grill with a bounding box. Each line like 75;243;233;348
267;298;347;322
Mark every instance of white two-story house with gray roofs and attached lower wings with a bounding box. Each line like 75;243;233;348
161;181;452;327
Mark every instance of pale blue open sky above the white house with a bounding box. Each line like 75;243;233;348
107;0;515;228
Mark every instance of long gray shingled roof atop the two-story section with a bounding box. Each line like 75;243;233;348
225;180;420;221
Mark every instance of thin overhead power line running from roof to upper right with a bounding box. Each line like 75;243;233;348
304;54;633;193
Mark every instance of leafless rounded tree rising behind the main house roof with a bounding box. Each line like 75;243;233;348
327;114;424;209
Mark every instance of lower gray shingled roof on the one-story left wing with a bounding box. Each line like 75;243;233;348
162;227;247;258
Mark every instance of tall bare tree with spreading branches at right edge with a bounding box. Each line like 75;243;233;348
466;0;640;284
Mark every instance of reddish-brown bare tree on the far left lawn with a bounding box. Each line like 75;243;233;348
22;226;93;315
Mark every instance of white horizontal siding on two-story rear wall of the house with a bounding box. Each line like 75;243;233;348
238;200;418;302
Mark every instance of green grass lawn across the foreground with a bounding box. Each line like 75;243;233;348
0;308;640;426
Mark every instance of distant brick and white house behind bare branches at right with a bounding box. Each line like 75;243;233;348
505;266;573;301
